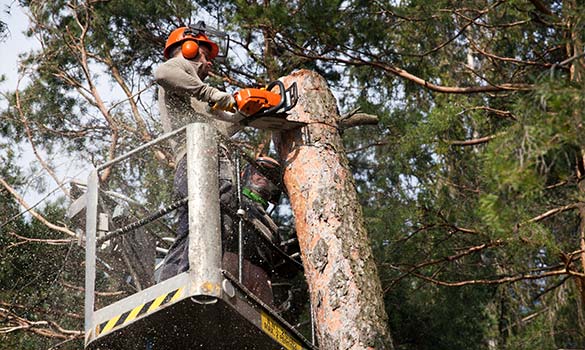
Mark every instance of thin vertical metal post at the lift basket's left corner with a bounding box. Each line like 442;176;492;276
85;169;99;339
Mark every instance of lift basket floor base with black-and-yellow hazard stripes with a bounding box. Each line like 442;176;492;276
86;272;315;350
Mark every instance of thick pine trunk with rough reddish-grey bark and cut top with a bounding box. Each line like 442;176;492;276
277;70;392;350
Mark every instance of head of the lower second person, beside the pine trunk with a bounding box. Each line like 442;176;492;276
242;157;281;204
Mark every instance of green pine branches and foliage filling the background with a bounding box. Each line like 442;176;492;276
0;0;585;349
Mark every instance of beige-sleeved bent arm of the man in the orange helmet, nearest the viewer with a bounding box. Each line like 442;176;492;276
154;57;229;103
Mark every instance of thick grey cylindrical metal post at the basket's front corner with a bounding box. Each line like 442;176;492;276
187;123;222;302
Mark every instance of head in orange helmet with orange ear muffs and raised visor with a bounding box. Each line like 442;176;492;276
163;27;219;79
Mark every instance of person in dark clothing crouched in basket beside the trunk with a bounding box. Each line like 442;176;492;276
223;157;281;305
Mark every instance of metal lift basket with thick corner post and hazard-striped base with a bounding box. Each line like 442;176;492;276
84;123;317;350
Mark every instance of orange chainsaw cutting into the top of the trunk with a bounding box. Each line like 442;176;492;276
234;80;305;130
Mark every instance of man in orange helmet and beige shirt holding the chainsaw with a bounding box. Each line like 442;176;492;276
154;22;243;280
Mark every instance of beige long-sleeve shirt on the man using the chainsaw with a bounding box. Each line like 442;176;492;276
154;56;243;162
